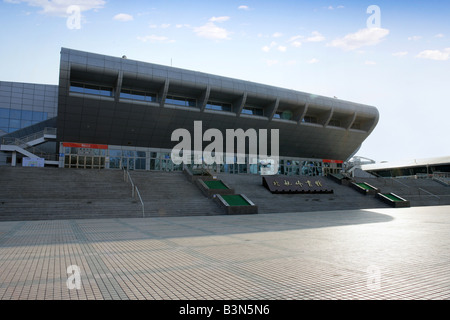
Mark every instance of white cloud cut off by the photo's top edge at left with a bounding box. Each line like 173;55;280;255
6;0;106;17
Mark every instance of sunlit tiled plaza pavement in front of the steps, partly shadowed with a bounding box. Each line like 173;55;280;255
0;206;450;300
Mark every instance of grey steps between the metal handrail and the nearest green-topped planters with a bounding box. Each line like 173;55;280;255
130;171;223;217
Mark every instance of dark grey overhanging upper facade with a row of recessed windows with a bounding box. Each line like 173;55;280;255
58;48;378;160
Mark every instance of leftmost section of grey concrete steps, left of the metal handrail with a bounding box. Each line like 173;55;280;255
0;167;142;221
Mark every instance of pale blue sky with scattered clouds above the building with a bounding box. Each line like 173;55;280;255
0;0;450;161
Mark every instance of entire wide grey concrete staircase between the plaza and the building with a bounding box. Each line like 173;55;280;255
0;167;450;221
